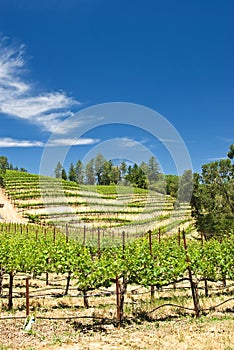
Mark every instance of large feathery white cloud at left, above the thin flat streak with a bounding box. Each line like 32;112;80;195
0;37;80;134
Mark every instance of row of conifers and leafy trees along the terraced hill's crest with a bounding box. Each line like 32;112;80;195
54;153;199;202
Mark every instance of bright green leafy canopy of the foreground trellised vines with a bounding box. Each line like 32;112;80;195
0;224;234;310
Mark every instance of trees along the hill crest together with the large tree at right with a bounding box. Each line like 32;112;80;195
55;144;234;239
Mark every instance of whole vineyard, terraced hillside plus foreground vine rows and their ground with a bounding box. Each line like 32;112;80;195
0;171;234;350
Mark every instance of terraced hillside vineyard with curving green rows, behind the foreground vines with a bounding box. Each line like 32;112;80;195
1;171;193;238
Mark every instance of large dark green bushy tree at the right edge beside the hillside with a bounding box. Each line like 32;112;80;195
191;146;234;238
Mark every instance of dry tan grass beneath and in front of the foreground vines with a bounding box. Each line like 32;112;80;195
0;275;234;350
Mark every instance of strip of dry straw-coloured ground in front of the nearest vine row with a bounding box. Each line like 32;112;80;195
0;314;234;350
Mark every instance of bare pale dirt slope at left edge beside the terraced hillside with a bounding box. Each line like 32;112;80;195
0;188;28;223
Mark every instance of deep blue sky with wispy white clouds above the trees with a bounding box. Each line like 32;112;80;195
0;0;234;173
